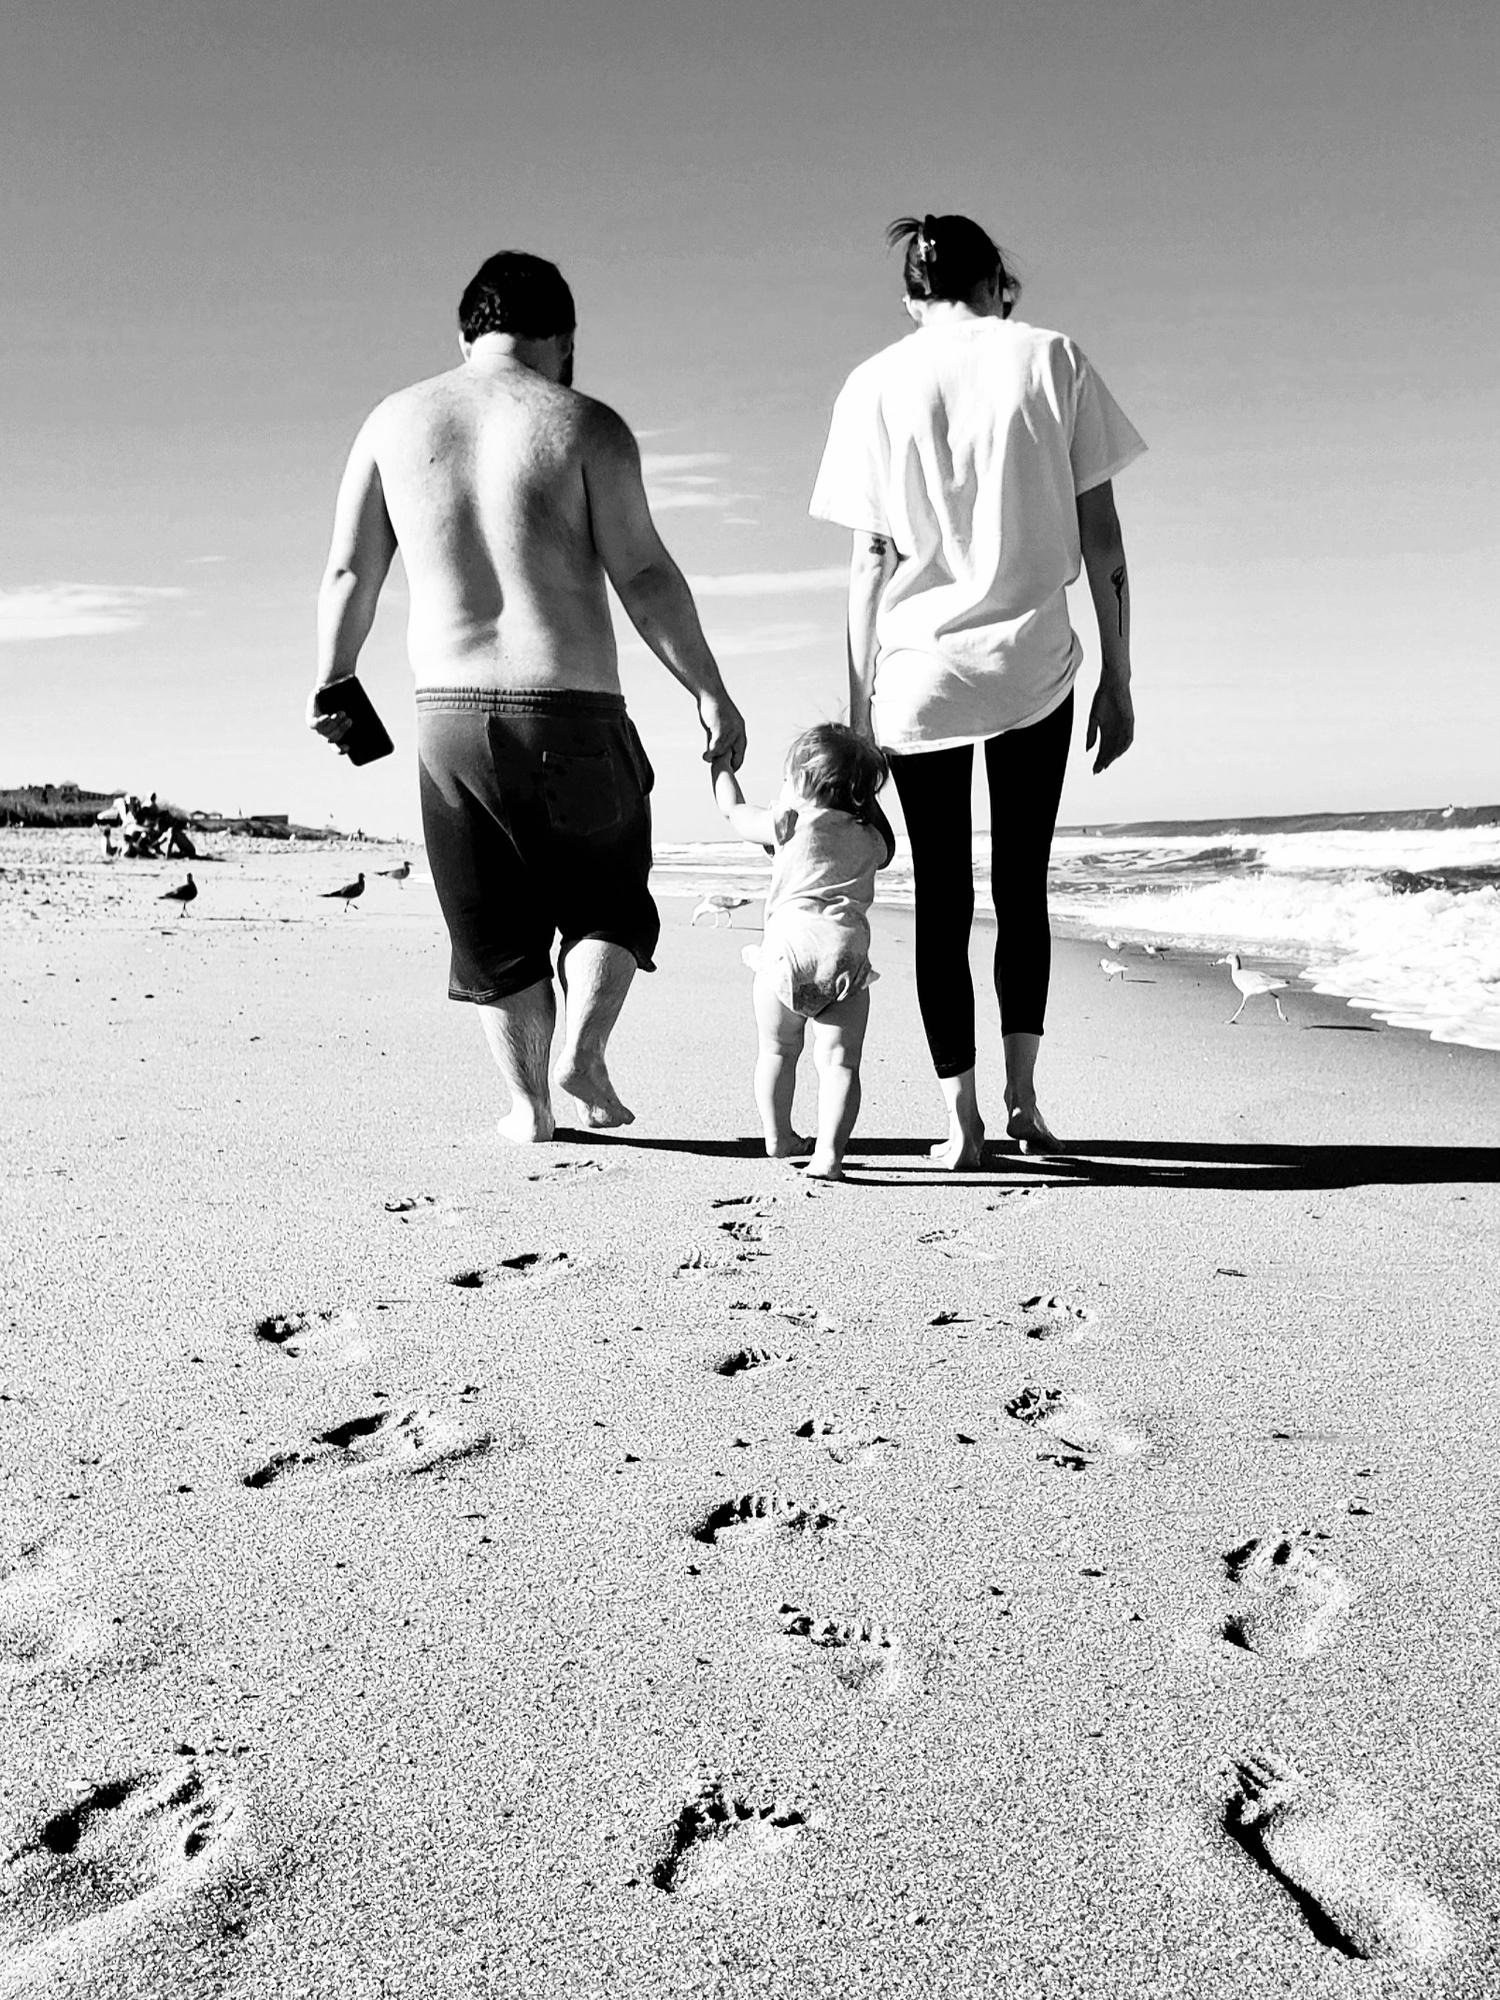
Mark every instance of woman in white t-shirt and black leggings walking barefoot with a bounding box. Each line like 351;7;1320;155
810;216;1146;1168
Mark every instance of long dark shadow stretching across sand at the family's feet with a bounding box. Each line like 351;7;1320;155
558;1130;1500;1192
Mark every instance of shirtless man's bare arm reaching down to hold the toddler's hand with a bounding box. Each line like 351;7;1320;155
584;404;744;770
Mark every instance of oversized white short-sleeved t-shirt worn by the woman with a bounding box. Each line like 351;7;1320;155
810;318;1146;752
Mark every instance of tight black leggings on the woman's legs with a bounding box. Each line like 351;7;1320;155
890;694;1072;1076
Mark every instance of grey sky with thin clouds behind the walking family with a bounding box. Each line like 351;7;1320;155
0;0;1500;840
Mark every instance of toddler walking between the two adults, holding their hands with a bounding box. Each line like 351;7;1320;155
714;722;896;1180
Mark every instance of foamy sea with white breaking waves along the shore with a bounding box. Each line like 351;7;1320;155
654;812;1500;1048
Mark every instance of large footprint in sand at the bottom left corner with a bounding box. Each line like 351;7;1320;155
0;1758;240;1960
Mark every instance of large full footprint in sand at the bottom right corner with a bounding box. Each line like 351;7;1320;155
1224;1754;1456;1966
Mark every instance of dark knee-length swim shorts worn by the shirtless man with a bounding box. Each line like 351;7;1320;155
416;688;662;1006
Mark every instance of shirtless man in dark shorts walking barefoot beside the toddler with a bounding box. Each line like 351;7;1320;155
308;250;744;1144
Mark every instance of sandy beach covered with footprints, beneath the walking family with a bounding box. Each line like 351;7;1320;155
0;832;1500;2000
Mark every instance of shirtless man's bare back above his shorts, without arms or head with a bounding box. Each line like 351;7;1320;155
368;356;620;694
